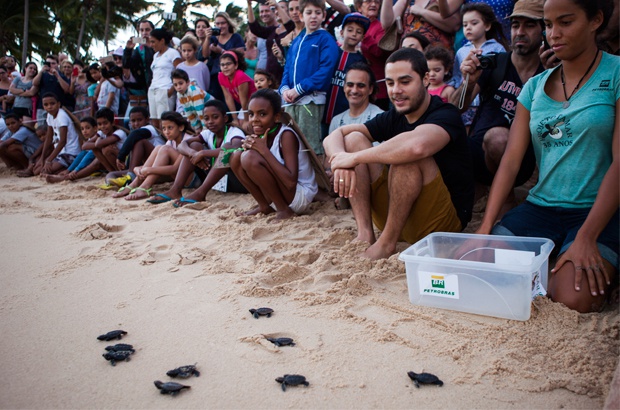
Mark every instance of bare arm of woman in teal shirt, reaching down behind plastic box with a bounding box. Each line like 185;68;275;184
476;103;531;234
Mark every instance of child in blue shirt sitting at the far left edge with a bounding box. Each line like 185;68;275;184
0;113;41;170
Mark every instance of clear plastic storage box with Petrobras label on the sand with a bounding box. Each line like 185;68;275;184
399;232;554;320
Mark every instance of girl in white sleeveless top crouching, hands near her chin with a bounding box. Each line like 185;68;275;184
230;89;318;219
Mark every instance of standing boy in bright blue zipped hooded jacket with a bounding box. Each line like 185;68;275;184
279;0;339;155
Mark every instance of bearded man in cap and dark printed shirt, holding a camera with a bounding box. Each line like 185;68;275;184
450;0;544;214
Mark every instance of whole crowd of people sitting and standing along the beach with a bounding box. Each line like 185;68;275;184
0;0;620;312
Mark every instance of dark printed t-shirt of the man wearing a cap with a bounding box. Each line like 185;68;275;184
470;52;544;137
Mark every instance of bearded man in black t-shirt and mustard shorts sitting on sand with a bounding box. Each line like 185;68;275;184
323;48;474;259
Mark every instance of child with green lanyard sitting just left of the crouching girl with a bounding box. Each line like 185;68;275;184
147;100;247;207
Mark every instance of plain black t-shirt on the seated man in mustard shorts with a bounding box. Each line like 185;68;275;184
364;96;474;228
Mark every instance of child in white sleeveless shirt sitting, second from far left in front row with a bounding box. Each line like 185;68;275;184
33;93;82;175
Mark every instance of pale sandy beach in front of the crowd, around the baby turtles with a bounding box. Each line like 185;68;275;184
0;166;620;409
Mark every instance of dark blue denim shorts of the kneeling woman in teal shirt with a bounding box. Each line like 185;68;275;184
491;201;620;270
